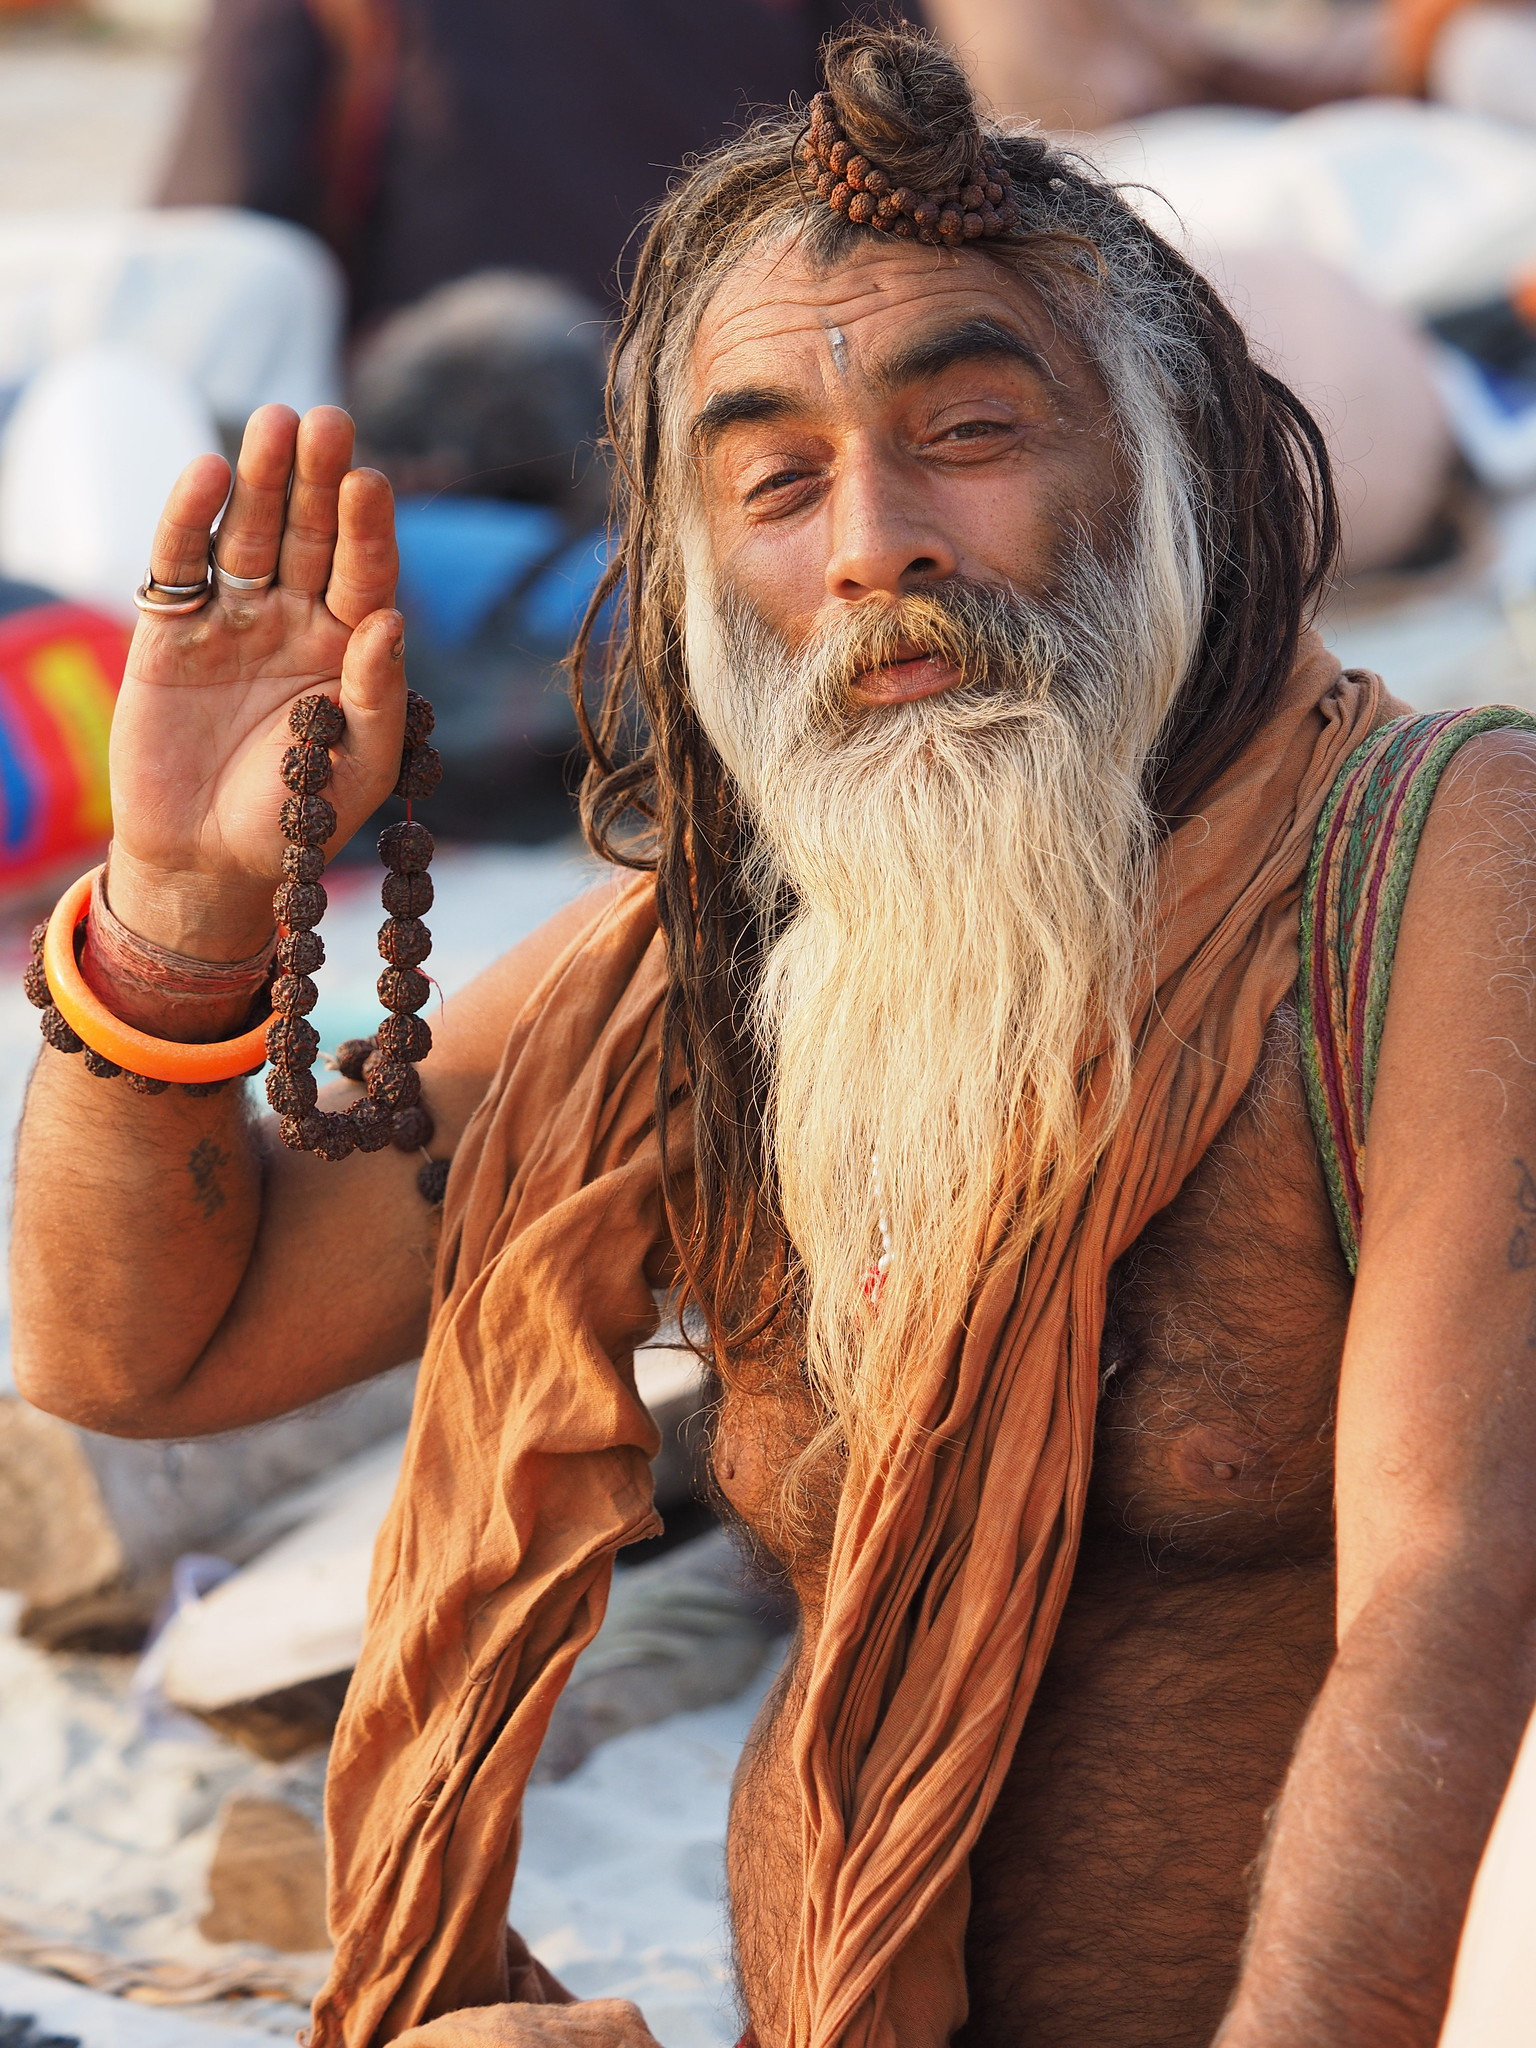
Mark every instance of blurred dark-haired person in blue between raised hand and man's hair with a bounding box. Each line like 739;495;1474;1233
352;270;608;840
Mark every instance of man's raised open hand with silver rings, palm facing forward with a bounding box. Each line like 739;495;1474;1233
111;406;406;961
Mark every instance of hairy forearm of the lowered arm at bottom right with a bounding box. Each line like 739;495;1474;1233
1217;1561;1536;2048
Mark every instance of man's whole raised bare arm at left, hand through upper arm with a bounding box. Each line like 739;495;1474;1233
12;406;460;1438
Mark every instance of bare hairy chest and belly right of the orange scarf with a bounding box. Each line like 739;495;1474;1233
956;1012;1350;2048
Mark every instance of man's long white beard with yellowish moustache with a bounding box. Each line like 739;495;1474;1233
688;561;1180;1452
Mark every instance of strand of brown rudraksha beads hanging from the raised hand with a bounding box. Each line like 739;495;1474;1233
266;690;442;1159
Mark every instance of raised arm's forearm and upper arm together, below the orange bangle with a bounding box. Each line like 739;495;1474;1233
12;1032;444;1438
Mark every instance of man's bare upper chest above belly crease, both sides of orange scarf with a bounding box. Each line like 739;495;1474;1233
715;1008;1350;1612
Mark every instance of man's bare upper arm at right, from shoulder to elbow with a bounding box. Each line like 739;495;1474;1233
1337;729;1536;1624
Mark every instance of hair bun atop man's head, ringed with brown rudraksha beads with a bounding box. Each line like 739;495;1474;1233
801;29;1020;248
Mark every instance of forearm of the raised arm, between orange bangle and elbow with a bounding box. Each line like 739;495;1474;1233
10;1047;262;1434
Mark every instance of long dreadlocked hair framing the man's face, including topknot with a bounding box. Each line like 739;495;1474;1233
571;27;1339;1370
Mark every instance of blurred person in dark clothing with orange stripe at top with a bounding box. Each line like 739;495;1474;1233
162;0;888;322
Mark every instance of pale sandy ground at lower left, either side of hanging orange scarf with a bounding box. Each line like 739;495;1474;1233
0;1581;772;2048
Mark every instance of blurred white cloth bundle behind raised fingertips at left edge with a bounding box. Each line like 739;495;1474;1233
0;207;342;616
